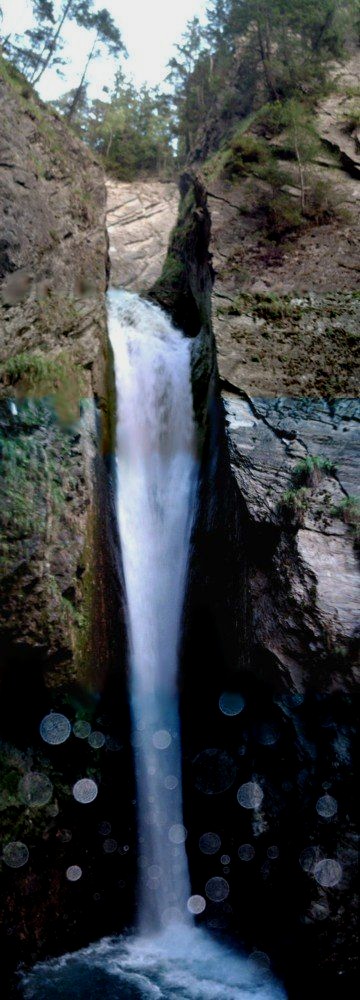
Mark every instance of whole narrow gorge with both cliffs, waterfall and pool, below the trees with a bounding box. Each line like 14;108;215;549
0;37;360;1000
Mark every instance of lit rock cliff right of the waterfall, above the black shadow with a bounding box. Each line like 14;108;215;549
205;47;360;690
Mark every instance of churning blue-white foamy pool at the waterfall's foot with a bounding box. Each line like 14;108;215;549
23;925;286;1000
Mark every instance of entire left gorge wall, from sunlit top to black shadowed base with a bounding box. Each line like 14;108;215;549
0;62;133;980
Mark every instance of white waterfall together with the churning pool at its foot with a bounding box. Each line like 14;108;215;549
22;291;285;1000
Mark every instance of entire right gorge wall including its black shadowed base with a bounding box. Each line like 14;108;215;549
148;135;359;1000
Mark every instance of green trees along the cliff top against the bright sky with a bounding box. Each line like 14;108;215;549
5;0;359;182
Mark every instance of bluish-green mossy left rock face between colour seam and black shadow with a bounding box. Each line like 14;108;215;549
0;400;97;699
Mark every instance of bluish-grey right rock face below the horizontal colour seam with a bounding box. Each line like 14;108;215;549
224;392;360;690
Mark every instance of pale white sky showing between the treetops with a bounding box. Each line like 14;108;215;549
1;0;207;101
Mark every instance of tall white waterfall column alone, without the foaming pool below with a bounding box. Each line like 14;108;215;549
110;291;197;932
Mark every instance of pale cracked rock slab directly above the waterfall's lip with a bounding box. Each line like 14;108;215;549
106;180;179;292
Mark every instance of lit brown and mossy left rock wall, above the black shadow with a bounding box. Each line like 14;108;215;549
0;76;108;688
